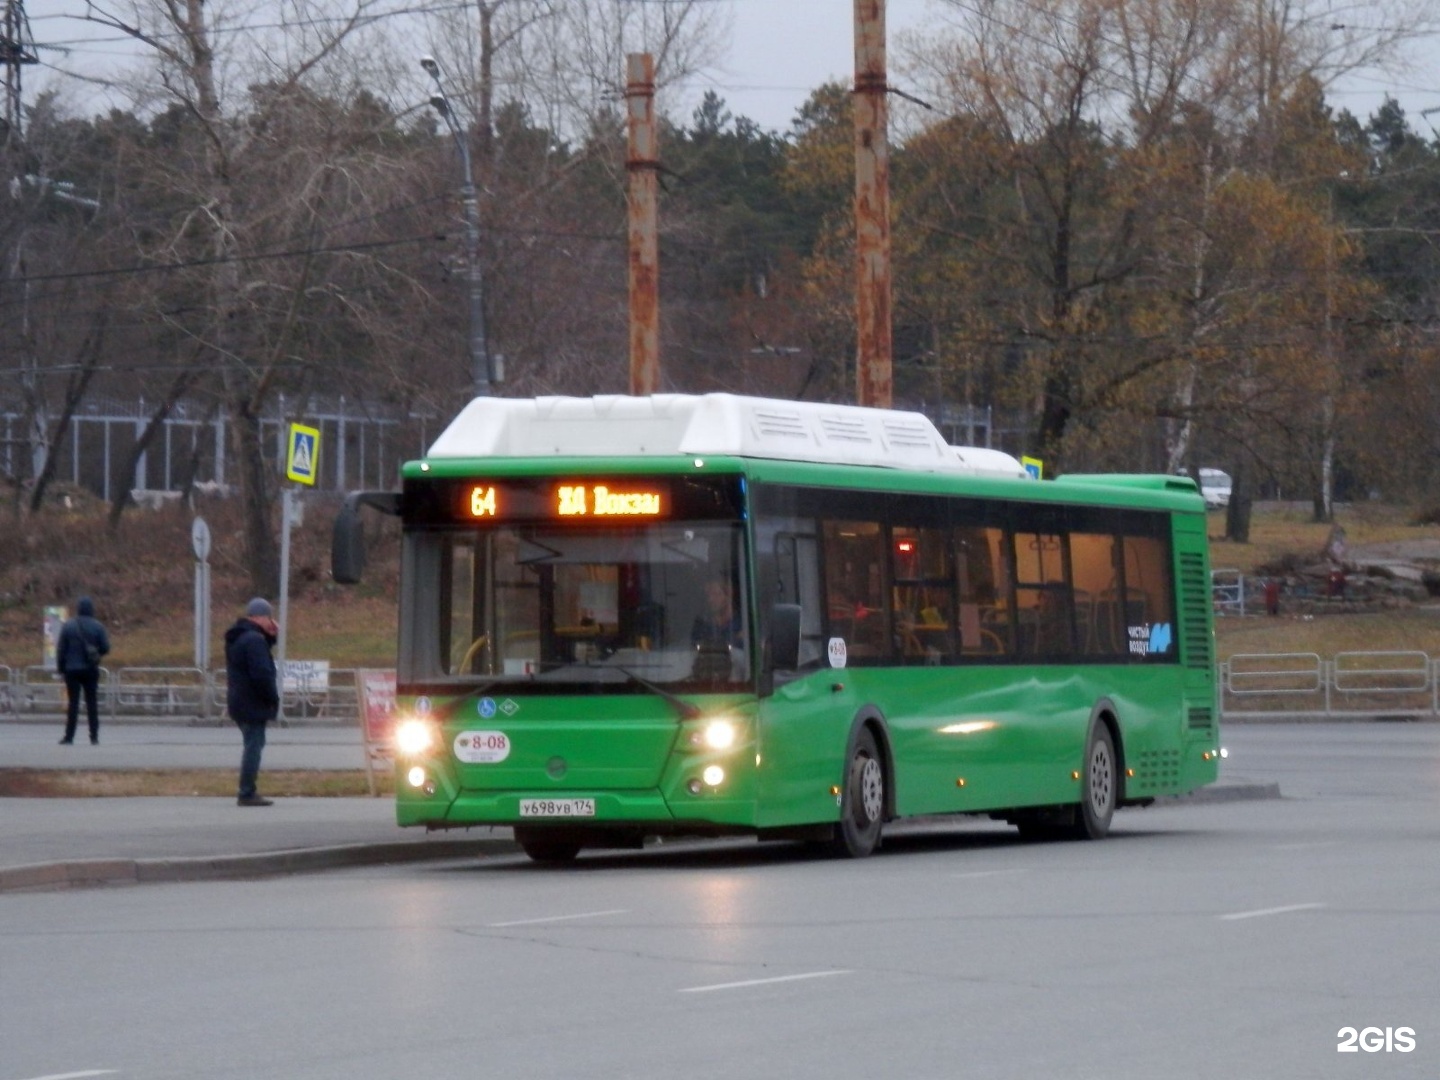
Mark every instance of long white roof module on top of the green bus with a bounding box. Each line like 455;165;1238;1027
429;393;1028;480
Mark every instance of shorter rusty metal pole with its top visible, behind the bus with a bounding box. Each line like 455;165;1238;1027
625;52;660;395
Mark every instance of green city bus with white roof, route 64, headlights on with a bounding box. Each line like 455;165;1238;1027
334;395;1218;861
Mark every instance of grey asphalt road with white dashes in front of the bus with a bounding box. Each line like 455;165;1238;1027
0;724;1440;1080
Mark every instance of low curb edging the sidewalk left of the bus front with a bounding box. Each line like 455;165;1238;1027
0;840;520;893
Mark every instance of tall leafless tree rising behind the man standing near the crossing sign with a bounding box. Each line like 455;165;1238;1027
88;0;420;593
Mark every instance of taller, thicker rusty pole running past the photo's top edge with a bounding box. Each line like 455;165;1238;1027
855;0;894;409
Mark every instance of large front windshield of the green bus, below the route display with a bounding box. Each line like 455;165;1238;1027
399;521;755;693
